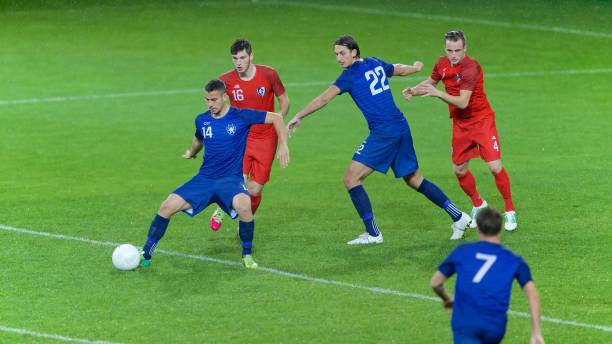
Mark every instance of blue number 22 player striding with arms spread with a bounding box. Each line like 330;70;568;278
287;36;471;245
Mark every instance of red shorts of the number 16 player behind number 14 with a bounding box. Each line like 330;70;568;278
242;135;277;185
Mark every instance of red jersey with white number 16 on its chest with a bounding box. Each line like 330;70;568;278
219;65;285;138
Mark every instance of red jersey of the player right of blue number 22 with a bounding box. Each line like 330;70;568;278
431;55;494;119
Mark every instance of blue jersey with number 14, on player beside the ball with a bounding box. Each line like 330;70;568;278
195;107;266;179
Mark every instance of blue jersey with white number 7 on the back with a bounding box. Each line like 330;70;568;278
438;241;531;330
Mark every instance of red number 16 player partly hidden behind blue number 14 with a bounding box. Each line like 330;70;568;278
210;39;289;231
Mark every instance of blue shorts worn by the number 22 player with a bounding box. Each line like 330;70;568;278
353;127;419;178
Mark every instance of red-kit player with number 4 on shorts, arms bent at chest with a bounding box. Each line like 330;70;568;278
403;31;517;231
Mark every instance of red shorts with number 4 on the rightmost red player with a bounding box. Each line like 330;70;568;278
452;115;501;165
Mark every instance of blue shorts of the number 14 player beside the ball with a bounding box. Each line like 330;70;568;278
173;175;249;219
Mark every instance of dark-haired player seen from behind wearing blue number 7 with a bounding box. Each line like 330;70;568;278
431;208;544;344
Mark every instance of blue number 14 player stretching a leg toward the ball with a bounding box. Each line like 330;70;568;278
141;80;289;268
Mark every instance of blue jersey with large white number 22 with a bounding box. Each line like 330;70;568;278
334;57;407;134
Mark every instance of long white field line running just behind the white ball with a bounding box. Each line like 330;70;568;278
0;225;612;333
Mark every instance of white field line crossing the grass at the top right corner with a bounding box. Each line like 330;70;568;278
262;1;612;38
